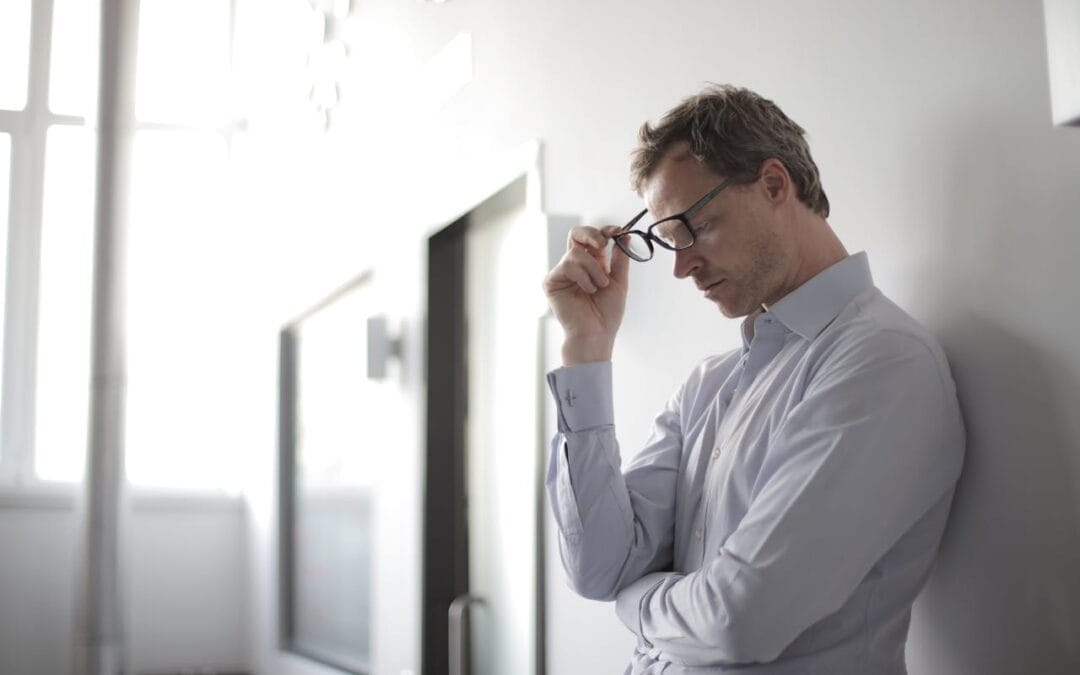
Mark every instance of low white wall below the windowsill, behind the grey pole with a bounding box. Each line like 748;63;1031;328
0;494;251;675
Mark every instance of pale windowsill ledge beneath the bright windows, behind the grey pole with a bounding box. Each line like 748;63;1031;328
0;483;244;513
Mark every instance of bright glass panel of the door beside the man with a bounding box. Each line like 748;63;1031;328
465;180;543;675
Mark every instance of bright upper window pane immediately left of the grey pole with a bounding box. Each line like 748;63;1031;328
49;0;102;117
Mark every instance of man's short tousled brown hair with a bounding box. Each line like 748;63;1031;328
631;84;828;217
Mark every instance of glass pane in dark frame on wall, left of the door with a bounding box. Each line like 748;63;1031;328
289;278;380;673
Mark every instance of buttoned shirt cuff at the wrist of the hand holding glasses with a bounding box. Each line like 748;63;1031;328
548;361;615;432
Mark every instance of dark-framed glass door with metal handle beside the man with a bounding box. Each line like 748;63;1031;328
423;178;548;675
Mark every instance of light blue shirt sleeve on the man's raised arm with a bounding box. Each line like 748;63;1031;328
545;362;683;600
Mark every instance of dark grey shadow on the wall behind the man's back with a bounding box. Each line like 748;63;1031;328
912;314;1080;675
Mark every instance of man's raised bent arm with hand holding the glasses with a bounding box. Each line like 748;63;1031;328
543;227;681;599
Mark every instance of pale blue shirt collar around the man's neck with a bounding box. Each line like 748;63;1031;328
747;252;874;340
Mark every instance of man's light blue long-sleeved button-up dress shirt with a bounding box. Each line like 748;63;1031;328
546;253;964;675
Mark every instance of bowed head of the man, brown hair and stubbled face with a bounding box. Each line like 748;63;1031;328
632;85;846;318
